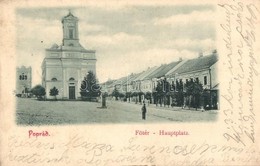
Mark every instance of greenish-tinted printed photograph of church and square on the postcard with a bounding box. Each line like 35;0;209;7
14;4;220;125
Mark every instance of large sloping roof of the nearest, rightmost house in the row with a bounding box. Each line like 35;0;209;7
172;54;218;74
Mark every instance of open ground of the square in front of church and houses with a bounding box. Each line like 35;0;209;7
16;98;218;125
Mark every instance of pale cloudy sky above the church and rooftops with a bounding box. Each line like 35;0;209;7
16;5;216;86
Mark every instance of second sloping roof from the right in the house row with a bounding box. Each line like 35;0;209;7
145;61;181;79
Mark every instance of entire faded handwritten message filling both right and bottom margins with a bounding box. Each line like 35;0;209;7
4;0;260;166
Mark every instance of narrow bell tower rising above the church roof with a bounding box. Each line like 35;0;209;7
61;11;80;46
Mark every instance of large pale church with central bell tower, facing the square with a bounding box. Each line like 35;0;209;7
42;12;97;100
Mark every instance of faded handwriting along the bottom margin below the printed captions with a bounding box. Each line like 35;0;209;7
6;135;260;166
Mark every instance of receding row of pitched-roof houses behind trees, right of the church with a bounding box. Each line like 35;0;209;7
102;50;219;109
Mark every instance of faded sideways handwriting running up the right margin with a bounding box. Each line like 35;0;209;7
218;0;259;146
